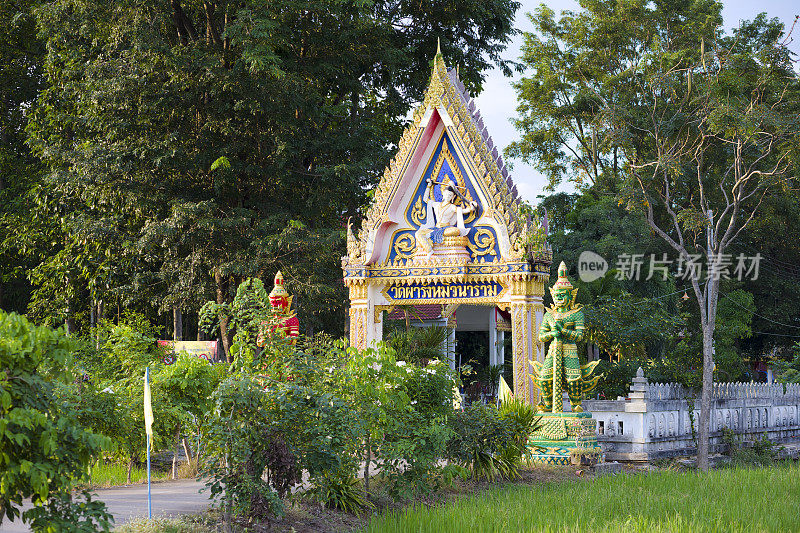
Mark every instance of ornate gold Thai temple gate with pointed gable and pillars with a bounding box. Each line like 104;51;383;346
342;48;552;404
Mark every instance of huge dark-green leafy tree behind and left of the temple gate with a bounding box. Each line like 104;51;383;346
23;0;518;346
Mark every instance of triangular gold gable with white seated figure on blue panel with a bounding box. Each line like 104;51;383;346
343;46;549;277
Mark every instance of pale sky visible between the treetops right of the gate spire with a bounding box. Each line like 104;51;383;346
476;0;800;204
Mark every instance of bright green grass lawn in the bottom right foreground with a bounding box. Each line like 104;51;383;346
366;463;800;533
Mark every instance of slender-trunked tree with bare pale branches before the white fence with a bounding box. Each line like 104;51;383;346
607;16;800;469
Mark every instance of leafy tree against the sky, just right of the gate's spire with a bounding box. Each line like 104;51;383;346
507;0;722;189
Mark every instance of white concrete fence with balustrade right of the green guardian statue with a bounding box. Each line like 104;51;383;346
583;369;800;461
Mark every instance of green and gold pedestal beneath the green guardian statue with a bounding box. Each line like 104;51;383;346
527;412;597;465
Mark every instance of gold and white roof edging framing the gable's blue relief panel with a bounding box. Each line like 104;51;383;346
347;45;546;274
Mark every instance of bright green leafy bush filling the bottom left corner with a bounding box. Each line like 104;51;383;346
0;312;113;530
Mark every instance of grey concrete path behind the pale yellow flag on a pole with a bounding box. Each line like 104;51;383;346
0;480;211;533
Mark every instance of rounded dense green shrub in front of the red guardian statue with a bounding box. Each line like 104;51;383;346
205;374;355;517
